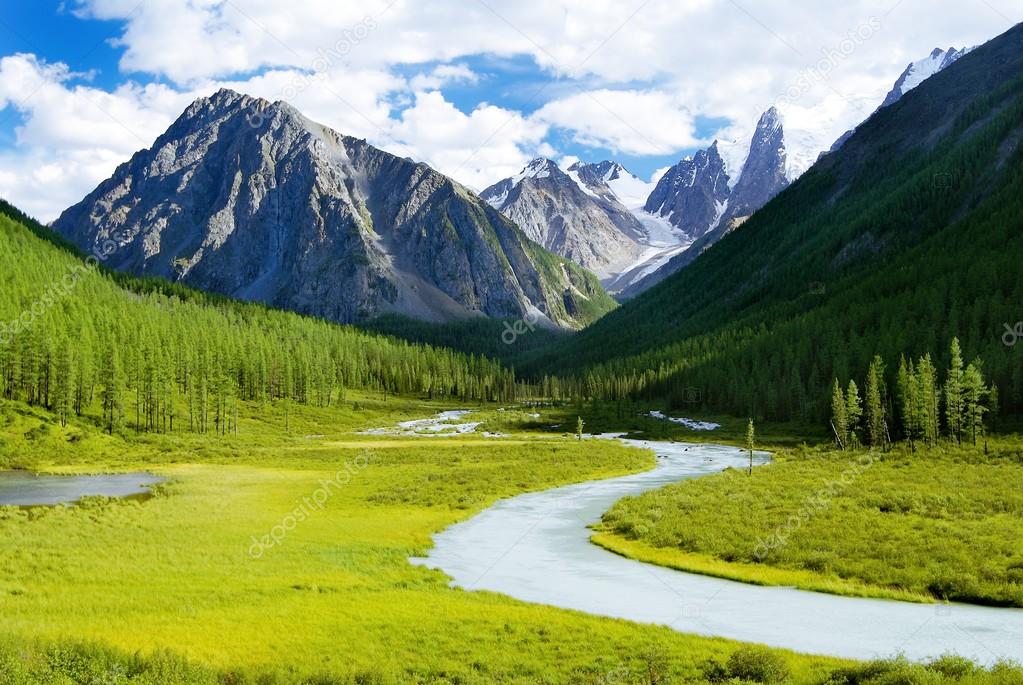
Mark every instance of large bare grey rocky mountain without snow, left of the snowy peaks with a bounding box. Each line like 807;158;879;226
53;90;614;327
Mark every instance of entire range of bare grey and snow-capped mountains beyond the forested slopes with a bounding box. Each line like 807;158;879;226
53;42;965;328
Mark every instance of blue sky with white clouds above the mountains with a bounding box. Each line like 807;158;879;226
0;0;1023;219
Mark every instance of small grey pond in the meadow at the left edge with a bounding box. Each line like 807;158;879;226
0;471;163;506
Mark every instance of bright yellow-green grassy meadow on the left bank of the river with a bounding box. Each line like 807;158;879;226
0;397;859;684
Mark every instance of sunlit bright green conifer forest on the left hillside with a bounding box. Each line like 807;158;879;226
0;203;516;432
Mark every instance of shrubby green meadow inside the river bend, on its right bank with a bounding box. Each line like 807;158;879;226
593;438;1023;606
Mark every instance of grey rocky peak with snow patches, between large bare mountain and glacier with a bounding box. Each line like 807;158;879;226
480;157;642;276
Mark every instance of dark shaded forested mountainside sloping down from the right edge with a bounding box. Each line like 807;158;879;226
529;22;1023;420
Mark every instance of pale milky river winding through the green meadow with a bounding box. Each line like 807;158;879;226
412;441;1023;664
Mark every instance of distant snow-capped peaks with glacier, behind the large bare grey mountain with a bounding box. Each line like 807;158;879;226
483;48;966;300
